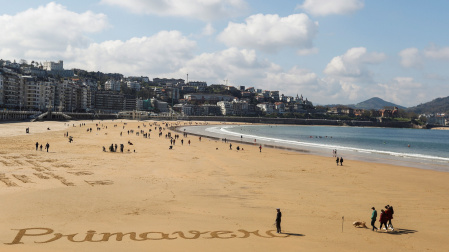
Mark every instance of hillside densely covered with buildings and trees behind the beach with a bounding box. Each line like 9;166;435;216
0;60;446;125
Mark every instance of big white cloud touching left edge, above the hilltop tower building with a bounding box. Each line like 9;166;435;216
0;2;109;58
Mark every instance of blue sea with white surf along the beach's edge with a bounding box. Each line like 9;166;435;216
181;124;449;172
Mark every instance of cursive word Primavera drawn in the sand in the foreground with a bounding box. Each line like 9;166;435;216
4;228;293;245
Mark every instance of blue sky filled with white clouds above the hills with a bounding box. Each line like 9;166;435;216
0;0;449;107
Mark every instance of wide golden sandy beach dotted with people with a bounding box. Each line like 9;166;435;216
0;120;449;251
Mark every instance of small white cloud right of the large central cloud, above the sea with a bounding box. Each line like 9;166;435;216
324;47;386;78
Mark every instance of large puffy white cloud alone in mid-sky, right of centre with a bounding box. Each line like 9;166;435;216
218;14;318;52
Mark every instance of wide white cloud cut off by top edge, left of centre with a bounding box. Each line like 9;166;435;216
101;0;248;21
